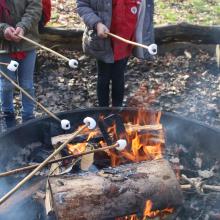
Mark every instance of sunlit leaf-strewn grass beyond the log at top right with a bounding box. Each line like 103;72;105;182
155;0;220;25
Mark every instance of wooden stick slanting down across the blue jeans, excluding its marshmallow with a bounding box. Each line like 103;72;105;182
0;70;61;122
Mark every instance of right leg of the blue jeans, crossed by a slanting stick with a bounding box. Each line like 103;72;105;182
18;50;36;122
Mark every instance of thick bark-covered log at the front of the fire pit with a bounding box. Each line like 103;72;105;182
50;159;182;220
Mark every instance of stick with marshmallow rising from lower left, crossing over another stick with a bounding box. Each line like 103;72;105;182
0;117;96;205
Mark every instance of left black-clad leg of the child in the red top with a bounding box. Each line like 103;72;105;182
97;60;112;107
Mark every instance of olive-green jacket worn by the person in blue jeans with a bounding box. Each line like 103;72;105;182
0;0;42;53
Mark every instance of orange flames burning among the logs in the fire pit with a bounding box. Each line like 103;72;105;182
65;111;173;220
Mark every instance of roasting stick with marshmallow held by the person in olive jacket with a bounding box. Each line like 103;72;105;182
19;35;78;68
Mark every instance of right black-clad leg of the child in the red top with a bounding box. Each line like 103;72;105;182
111;58;128;106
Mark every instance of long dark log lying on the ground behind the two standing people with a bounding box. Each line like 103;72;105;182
41;23;220;49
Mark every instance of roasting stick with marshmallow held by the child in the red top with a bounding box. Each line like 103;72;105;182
106;33;157;55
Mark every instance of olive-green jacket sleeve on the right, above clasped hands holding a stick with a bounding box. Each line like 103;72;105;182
16;0;42;33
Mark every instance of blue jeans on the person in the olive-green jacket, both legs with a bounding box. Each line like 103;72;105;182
0;50;36;121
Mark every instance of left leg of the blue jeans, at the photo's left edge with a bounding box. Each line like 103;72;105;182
0;54;16;113
